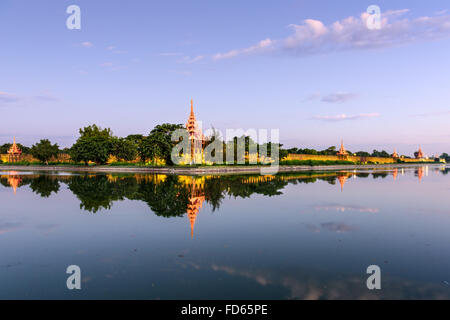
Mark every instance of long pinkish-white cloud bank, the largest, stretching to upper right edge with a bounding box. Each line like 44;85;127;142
213;9;450;60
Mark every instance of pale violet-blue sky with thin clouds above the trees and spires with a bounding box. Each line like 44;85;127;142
0;0;450;155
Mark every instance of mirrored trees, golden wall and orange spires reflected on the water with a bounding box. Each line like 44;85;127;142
0;166;442;237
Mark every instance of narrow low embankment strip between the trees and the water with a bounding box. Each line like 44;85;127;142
0;163;445;175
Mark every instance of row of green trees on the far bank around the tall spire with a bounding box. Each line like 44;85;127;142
0;123;450;165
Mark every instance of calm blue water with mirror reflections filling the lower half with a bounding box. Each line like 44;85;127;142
0;166;450;299
